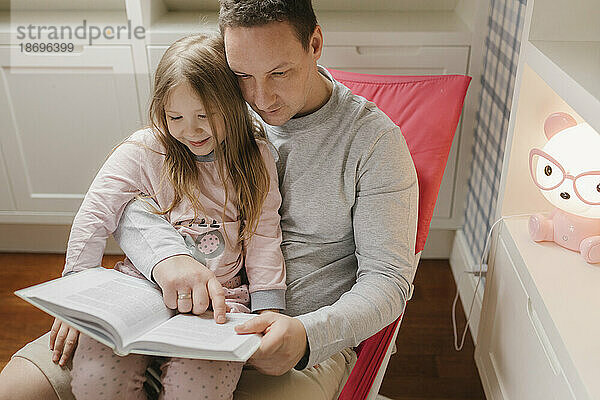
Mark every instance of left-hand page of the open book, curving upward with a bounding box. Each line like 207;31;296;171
17;268;175;345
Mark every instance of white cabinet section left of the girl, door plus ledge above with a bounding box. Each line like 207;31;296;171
0;0;145;223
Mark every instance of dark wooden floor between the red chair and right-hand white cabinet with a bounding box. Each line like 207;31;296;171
379;260;485;400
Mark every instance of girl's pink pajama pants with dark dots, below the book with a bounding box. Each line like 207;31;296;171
71;267;250;400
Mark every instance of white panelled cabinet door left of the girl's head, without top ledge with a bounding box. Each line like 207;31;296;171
0;45;142;223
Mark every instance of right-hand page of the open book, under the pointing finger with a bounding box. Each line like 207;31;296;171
132;312;261;360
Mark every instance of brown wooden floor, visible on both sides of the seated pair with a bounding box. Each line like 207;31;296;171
0;254;485;400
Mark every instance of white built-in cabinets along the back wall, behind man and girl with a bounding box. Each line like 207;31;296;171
0;0;489;256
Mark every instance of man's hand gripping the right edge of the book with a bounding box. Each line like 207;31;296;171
235;312;306;375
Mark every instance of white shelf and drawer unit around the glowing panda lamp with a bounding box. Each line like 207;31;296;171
475;0;600;400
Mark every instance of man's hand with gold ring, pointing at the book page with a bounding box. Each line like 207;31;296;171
152;255;226;324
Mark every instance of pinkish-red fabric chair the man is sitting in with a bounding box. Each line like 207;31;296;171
330;70;471;400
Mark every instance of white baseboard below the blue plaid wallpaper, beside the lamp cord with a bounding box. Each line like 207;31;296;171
450;230;484;345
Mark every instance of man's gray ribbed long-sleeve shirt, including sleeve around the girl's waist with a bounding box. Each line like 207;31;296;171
118;68;418;366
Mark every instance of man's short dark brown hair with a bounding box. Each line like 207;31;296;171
219;0;317;50
